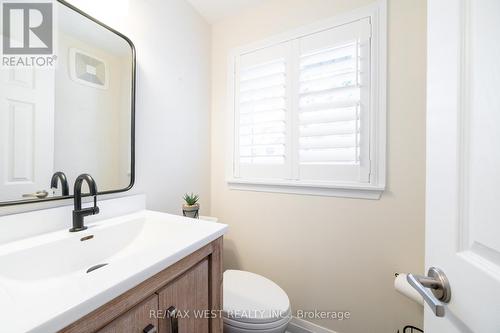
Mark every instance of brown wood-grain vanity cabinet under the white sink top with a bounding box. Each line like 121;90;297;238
60;237;223;333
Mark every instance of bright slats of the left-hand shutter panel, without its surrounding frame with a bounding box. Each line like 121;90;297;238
239;59;286;164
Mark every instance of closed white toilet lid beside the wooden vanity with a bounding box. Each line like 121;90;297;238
223;270;290;324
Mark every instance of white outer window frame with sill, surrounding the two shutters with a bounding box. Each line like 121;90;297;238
226;0;387;199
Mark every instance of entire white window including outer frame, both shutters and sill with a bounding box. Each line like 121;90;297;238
228;5;386;198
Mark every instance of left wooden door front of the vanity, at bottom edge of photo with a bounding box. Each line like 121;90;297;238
98;294;158;333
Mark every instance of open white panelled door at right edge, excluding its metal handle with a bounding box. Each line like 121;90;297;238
425;0;500;333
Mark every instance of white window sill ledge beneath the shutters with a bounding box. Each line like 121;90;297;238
227;178;385;200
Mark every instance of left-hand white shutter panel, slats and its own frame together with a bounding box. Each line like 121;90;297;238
235;43;290;178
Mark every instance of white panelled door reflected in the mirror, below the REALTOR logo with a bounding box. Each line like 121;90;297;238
0;68;54;201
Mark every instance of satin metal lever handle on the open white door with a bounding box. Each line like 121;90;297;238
406;267;451;317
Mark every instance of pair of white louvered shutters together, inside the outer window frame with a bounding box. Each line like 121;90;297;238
232;18;373;185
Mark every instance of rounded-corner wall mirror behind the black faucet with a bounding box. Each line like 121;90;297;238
0;1;135;205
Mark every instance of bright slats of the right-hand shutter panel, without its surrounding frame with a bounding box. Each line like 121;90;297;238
298;40;360;165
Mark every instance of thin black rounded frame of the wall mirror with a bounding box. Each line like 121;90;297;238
0;0;136;207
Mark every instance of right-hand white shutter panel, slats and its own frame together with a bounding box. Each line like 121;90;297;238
297;19;370;182
